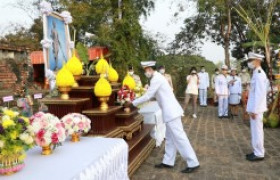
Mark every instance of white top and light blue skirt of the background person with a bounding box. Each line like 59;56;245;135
228;76;242;105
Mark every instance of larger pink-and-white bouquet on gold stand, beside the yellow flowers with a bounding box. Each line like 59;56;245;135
30;112;66;155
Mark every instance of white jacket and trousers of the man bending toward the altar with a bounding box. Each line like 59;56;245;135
132;72;199;167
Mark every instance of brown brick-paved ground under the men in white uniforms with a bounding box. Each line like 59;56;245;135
132;107;280;180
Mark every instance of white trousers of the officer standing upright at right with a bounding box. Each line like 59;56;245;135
250;113;265;157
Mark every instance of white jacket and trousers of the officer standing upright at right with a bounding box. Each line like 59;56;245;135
247;67;268;157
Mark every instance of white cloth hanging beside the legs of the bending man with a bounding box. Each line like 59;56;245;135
139;101;166;147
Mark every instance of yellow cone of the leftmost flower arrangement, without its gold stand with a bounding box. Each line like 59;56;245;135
56;65;75;87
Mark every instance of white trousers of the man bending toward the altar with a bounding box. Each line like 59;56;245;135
162;117;199;167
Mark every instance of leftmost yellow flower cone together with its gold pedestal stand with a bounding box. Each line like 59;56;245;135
56;65;75;100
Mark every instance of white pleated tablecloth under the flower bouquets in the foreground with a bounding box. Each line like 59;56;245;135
4;137;129;180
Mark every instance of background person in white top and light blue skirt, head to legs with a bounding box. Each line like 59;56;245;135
228;68;242;115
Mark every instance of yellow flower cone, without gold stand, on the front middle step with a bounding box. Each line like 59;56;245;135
94;75;112;97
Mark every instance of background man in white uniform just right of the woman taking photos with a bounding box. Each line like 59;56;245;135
198;66;209;107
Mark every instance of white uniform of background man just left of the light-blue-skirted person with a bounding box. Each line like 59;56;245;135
215;74;230;117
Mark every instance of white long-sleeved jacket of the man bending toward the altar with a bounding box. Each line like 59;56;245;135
132;72;184;122
